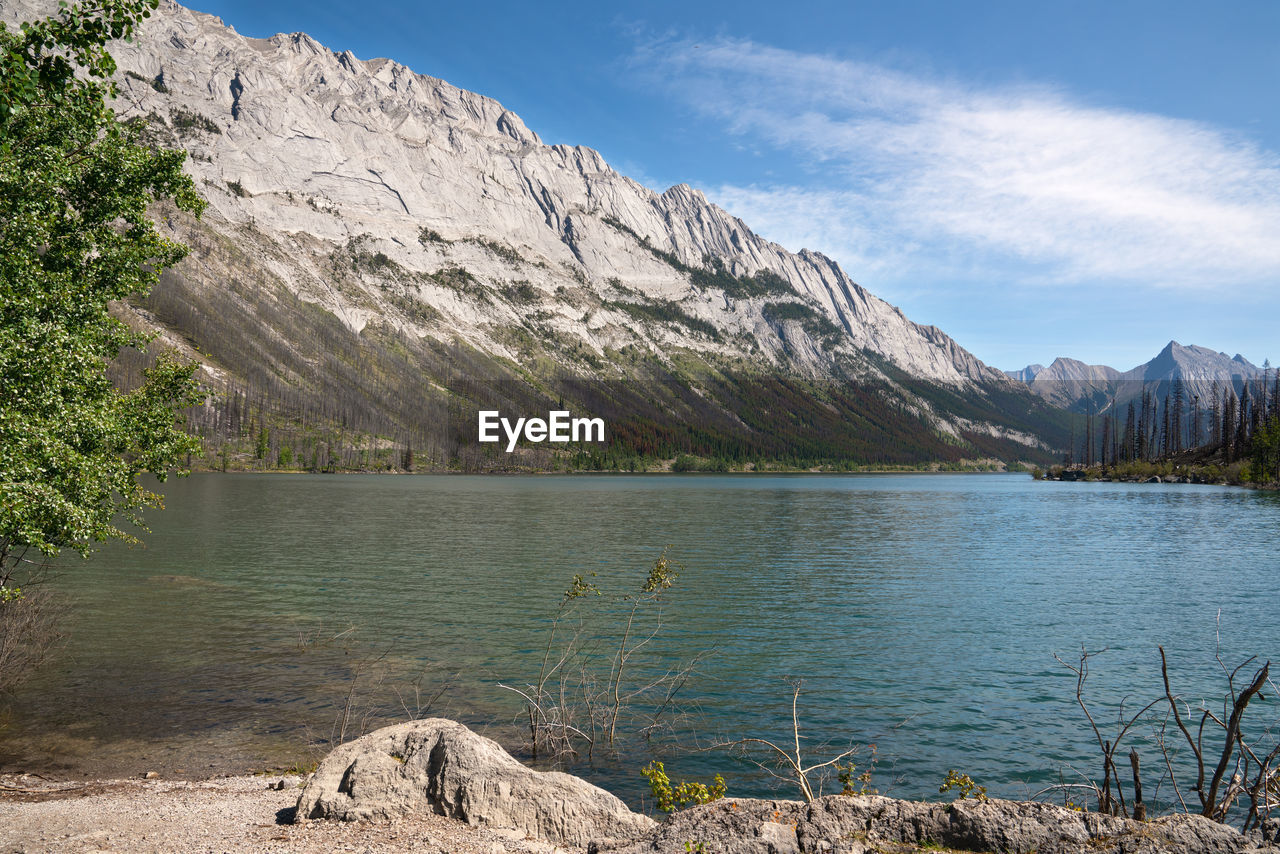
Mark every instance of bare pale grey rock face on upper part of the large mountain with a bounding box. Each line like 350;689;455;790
74;1;1009;387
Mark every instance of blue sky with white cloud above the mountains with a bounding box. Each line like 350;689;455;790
191;0;1280;370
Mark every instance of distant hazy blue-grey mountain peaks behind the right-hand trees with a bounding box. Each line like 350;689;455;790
1005;341;1265;412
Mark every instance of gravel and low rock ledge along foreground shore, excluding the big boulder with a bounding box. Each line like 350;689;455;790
0;773;1280;854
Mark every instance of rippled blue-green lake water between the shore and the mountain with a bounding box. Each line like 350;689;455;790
0;475;1280;796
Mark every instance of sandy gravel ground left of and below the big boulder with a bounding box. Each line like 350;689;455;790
0;775;558;854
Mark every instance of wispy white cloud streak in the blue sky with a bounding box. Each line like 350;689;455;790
636;40;1280;288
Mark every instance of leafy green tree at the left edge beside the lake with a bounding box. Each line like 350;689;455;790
0;0;204;686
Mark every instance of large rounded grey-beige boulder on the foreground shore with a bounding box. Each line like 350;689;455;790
296;718;654;846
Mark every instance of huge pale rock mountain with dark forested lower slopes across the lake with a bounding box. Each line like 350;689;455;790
0;0;1064;467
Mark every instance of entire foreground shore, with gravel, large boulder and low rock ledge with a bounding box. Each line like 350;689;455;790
0;718;1280;854
